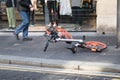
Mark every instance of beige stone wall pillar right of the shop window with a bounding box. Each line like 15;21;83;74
96;0;117;33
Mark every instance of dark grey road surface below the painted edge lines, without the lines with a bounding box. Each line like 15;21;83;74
0;70;114;80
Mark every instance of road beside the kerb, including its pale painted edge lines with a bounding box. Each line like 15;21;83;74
0;64;120;80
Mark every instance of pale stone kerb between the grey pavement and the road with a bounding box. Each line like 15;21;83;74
0;55;120;73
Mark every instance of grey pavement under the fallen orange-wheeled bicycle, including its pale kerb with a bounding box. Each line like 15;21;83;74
0;32;120;73
